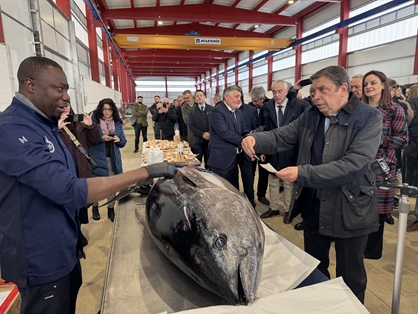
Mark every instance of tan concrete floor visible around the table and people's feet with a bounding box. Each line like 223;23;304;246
77;127;418;314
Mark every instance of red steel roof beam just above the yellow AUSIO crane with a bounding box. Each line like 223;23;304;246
113;23;271;38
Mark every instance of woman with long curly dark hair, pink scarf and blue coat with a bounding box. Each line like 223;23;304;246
90;98;126;221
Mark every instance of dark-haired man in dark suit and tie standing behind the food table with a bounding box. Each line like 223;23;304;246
188;89;213;169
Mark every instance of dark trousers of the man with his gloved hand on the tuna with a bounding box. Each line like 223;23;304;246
19;259;82;314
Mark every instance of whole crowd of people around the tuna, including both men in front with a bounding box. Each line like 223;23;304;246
0;57;418;313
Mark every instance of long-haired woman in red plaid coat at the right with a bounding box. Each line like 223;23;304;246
363;71;408;259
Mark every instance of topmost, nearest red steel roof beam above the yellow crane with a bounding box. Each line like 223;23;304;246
102;4;296;25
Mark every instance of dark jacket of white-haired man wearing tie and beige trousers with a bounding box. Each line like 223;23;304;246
260;98;308;170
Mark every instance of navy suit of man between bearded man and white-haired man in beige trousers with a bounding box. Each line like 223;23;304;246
238;104;258;207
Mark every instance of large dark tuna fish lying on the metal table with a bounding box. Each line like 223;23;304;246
146;167;264;304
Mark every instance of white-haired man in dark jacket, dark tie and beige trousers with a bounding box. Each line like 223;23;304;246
260;80;307;224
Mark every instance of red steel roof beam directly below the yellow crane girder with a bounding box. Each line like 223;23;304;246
123;49;236;61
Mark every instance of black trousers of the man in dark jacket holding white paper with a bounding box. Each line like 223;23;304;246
303;197;368;303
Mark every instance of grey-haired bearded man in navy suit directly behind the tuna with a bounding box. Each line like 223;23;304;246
208;85;243;189
